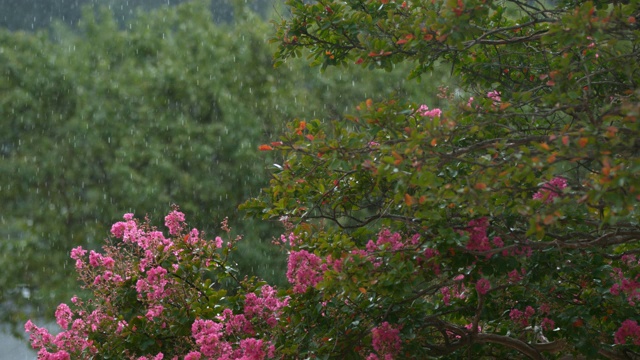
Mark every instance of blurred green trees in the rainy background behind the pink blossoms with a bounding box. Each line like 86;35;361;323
0;1;440;332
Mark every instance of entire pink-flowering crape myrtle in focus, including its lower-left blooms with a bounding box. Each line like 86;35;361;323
21;0;640;360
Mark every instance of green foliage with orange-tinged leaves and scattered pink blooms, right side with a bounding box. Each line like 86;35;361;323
244;0;640;358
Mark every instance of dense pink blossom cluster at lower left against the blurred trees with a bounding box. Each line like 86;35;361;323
25;209;280;360
